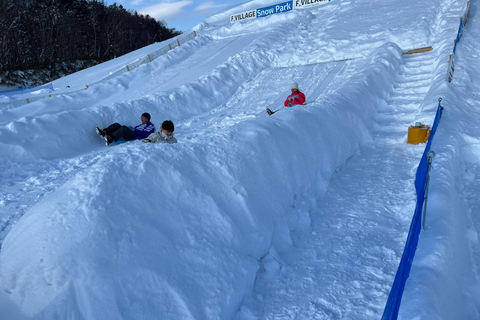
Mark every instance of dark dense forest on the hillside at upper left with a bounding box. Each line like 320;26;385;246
0;0;181;71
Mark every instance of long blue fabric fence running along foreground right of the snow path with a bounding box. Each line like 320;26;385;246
382;102;443;320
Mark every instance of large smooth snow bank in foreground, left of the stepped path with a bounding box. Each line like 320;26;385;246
0;44;401;319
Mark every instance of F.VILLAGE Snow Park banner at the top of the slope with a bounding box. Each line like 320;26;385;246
230;0;331;23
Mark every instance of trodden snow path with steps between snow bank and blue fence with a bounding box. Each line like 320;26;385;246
239;51;435;320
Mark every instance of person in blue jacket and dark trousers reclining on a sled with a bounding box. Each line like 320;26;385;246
96;112;155;145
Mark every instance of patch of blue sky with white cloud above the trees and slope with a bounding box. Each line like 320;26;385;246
112;0;247;31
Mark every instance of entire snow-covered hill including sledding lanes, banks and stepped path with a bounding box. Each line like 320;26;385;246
0;0;480;320
